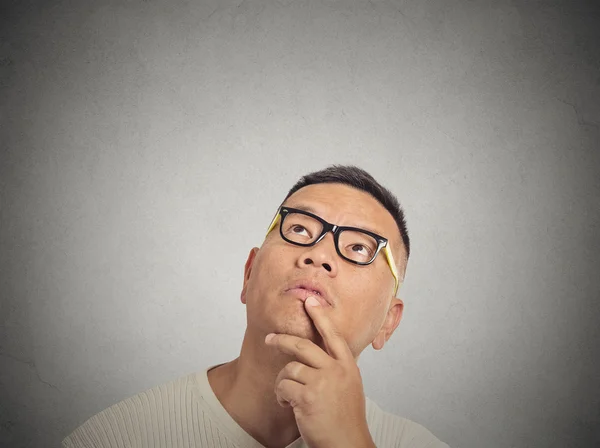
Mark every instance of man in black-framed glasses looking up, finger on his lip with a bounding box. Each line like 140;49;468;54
63;166;448;448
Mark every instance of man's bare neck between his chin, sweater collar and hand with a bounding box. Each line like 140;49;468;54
208;329;300;448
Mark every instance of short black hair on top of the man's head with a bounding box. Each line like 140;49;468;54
283;165;410;261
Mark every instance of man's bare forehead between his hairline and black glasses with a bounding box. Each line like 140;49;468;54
285;183;400;243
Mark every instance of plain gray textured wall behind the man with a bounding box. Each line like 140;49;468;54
0;0;600;448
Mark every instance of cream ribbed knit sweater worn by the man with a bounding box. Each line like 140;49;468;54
62;366;448;448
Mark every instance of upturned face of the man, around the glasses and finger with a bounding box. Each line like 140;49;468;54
242;184;405;357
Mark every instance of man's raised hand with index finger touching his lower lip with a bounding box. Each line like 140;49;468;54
265;297;375;448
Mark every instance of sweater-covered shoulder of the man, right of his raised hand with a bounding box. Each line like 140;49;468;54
366;398;449;448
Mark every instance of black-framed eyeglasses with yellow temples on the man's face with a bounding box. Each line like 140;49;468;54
267;207;399;291
